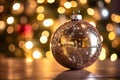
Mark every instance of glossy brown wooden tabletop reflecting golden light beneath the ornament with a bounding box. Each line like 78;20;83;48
0;58;120;80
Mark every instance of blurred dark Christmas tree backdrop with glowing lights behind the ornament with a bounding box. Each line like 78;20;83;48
0;0;120;61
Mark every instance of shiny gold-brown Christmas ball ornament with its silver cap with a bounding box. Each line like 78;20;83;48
51;14;102;69
